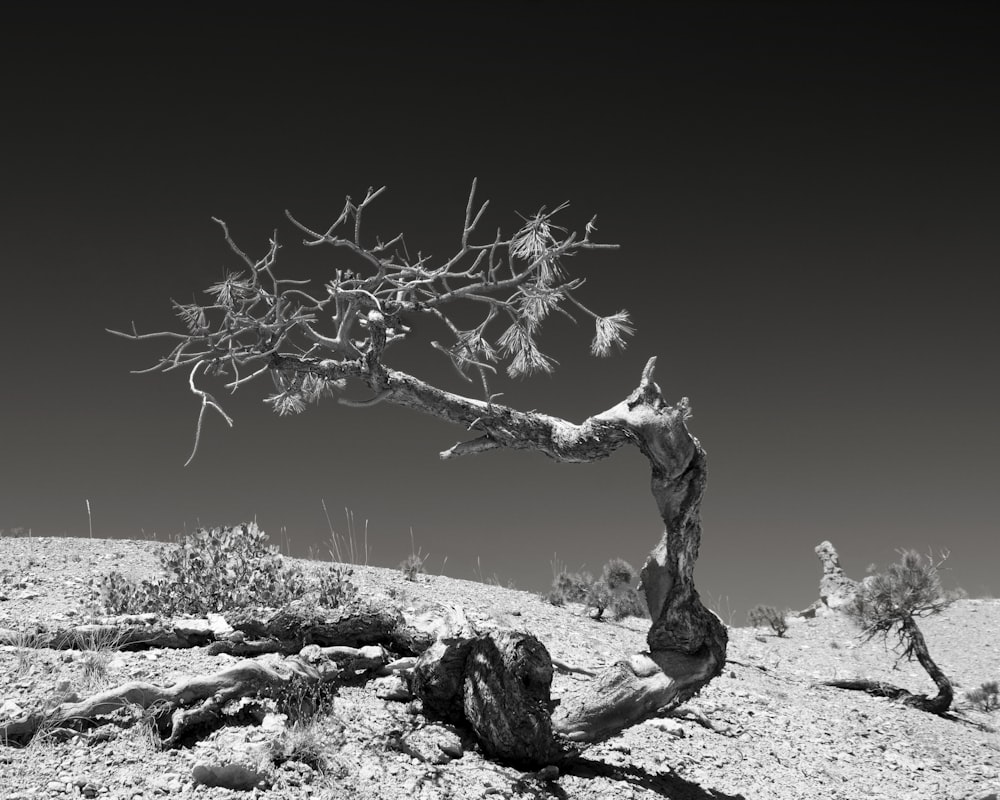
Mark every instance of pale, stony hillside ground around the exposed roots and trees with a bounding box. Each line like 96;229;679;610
0;538;1000;800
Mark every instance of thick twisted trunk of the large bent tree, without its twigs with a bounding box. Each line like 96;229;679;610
282;356;728;764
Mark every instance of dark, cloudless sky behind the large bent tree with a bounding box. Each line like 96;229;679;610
0;0;1000;622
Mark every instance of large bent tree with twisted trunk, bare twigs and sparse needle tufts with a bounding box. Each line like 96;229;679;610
112;182;727;760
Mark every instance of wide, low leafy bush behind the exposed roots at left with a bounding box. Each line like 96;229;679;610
90;522;353;615
